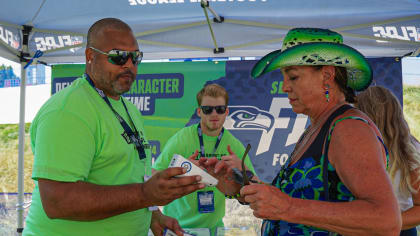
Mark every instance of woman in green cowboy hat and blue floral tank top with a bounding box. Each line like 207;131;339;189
201;28;401;236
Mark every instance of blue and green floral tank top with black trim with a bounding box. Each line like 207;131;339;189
262;105;380;236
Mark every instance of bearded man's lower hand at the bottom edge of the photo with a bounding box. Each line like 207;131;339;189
150;210;184;236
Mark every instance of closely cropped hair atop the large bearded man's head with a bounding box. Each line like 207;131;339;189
86;18;132;48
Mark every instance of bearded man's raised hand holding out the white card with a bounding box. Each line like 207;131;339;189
141;167;205;206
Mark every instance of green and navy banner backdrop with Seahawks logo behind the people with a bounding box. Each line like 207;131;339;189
51;58;402;182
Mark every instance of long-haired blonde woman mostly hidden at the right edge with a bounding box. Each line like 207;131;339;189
356;86;420;236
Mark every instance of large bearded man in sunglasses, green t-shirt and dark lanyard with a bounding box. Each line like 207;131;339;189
23;18;204;236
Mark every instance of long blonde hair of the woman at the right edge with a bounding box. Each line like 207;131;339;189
355;86;420;194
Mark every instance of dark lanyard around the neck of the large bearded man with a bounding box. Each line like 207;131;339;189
85;74;147;160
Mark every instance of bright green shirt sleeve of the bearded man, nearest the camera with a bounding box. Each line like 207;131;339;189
32;110;95;182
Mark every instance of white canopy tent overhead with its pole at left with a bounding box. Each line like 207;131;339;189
0;0;420;231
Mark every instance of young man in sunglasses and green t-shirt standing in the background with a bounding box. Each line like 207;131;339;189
153;84;254;235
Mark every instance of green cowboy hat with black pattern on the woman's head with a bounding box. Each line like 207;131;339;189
251;28;372;91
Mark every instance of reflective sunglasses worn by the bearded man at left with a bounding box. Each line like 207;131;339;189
89;47;143;66
